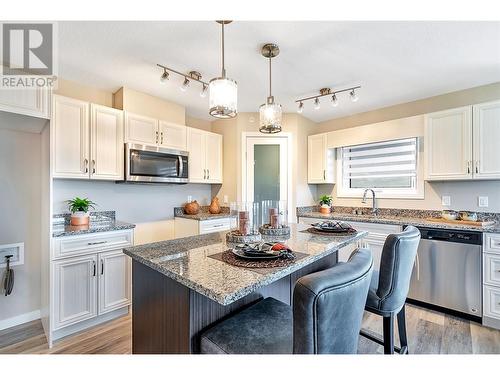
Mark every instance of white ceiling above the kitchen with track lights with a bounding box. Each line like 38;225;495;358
58;21;500;122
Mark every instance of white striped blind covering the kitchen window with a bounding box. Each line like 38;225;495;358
342;138;417;184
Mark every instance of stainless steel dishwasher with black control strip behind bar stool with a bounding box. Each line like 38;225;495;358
408;227;483;320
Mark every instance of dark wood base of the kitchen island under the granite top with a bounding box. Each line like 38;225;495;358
132;253;337;354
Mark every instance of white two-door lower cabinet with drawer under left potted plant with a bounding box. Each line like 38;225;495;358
52;231;133;330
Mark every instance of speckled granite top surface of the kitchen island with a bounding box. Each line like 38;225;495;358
124;224;367;305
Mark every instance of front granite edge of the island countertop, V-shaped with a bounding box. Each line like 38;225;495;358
123;232;368;306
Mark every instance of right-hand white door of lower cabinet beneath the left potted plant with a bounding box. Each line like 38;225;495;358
99;250;132;315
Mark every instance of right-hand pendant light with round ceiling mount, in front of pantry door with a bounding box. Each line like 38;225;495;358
259;43;282;133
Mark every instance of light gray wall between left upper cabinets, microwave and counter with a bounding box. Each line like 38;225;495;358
53;180;211;223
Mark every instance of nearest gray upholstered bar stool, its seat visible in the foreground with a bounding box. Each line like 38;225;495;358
201;249;373;354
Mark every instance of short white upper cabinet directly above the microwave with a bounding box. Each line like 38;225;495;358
125;112;186;150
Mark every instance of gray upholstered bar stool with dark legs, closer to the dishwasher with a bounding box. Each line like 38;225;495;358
361;226;420;354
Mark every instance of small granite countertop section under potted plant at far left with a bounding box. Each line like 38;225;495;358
52;211;135;237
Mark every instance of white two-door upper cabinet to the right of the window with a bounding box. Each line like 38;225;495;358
425;101;500;180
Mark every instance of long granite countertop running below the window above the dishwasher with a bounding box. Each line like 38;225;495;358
297;210;500;233
